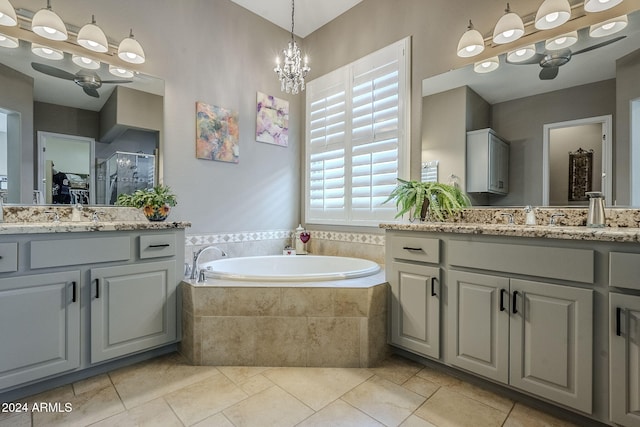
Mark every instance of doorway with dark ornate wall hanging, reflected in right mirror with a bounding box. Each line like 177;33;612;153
542;116;612;206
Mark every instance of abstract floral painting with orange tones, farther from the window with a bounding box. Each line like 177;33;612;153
196;101;240;163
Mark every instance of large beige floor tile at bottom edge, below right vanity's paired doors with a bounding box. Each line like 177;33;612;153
415;387;507;427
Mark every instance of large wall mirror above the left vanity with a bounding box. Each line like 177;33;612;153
0;40;164;204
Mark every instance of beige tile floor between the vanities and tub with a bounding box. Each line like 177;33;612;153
0;354;574;427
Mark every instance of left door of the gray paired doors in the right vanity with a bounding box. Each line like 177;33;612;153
447;270;509;384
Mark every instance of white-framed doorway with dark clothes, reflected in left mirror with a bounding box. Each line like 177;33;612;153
38;131;95;204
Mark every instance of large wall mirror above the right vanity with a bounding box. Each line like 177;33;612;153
422;6;640;206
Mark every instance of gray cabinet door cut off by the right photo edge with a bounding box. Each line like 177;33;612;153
609;293;640;427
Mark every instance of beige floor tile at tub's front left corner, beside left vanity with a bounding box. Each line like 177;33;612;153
109;354;220;409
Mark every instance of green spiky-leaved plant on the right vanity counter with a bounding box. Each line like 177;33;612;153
384;178;471;221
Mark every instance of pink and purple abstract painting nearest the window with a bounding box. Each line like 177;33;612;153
256;92;289;147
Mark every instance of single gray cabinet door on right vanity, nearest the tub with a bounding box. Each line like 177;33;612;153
389;262;441;358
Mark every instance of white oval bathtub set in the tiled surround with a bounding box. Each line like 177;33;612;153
200;255;380;283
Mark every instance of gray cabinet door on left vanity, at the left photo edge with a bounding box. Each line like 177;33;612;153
0;271;80;390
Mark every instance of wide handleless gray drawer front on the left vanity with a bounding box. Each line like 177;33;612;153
30;236;131;268
